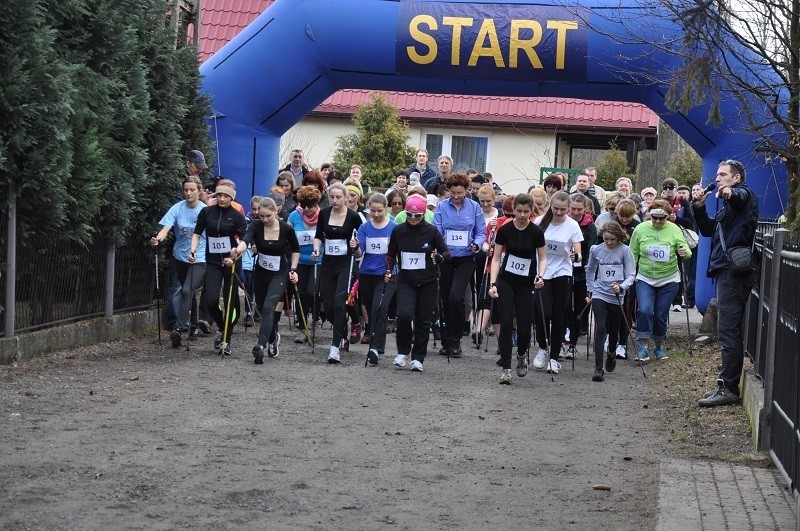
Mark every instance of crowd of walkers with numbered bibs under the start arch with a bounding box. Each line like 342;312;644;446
151;149;760;405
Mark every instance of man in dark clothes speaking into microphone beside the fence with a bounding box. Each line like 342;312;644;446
694;160;758;407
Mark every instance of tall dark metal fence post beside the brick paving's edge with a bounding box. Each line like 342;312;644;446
758;229;789;452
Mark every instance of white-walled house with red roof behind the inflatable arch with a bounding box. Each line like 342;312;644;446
192;0;659;193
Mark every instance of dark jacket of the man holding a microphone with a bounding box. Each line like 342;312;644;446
694;183;758;278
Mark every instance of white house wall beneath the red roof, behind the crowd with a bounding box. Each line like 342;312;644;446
281;118;556;193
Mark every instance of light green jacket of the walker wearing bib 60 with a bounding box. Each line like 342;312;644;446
630;221;692;279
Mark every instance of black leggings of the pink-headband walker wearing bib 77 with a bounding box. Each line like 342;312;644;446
396;281;439;363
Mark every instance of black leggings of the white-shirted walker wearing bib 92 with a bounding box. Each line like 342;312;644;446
536;275;572;361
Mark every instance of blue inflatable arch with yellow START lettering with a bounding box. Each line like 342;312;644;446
201;0;787;310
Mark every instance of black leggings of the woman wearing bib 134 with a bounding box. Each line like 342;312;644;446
438;256;475;349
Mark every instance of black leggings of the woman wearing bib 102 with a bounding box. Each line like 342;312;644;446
495;276;533;369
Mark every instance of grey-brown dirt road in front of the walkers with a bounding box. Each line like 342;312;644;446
0;330;664;529
